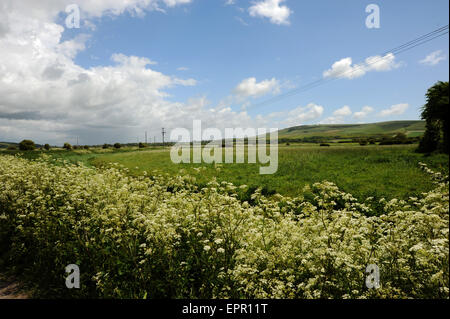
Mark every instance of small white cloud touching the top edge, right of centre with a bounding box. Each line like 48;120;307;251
248;0;292;25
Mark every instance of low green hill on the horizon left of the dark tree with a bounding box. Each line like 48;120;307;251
278;121;425;139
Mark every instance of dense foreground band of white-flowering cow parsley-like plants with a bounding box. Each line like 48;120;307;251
0;156;449;298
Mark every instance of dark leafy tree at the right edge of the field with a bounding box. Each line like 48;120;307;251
417;81;449;154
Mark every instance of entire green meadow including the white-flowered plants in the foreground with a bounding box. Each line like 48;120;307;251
0;136;449;299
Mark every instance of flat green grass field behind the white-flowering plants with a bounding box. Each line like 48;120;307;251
5;144;448;200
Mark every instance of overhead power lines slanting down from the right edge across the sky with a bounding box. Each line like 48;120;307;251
247;24;449;109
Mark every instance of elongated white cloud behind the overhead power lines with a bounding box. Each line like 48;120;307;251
323;53;400;79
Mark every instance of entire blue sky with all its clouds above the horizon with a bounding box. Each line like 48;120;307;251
0;0;449;145
